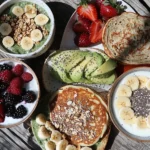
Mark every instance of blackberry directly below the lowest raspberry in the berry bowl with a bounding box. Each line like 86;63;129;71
3;93;21;105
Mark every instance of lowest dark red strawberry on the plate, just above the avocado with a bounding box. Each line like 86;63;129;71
74;33;91;47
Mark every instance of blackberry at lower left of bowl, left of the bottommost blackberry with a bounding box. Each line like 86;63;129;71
5;104;16;117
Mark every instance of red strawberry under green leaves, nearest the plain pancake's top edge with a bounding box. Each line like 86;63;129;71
100;4;118;18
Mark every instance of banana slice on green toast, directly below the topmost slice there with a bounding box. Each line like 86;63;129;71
38;126;51;140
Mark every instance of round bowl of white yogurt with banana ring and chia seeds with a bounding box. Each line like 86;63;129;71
108;67;150;141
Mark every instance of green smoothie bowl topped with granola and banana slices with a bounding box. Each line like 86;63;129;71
0;0;55;59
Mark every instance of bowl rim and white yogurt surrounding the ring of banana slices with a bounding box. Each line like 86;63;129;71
108;67;150;142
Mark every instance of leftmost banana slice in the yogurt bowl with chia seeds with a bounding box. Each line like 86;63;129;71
116;96;131;110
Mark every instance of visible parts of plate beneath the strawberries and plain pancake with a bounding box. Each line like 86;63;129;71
60;0;135;50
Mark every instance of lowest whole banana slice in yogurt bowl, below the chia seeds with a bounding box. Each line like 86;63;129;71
136;116;148;129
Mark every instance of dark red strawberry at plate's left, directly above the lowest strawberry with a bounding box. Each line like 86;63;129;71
73;16;91;33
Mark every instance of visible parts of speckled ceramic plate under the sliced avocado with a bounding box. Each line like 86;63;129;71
42;48;111;93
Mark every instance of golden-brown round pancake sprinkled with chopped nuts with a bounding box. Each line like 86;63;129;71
50;85;109;146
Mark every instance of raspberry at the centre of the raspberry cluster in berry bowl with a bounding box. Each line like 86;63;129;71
10;77;23;88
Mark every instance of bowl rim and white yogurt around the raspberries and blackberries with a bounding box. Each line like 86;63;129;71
0;58;40;128
